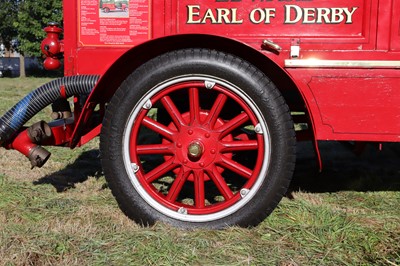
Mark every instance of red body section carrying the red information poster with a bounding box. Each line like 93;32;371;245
63;0;158;75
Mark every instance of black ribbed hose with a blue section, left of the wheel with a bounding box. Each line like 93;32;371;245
0;75;100;145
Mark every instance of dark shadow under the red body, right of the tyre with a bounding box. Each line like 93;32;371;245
290;142;400;193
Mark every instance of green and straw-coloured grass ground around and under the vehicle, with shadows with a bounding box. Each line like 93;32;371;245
0;79;400;266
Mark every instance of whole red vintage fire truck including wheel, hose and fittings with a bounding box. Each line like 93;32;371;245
0;0;400;228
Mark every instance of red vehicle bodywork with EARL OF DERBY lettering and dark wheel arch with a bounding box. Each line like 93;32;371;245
64;0;400;142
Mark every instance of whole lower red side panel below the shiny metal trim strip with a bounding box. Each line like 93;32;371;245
289;69;400;141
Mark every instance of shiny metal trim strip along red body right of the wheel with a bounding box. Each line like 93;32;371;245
285;59;400;68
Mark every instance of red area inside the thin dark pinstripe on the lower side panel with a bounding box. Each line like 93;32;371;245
308;76;400;135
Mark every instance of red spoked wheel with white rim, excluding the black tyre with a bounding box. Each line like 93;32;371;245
124;77;270;222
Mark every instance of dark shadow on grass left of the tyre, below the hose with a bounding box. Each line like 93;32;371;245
33;149;103;192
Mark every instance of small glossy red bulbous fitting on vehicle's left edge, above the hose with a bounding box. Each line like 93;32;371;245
40;22;64;70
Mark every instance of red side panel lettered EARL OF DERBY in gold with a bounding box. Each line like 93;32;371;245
176;0;378;49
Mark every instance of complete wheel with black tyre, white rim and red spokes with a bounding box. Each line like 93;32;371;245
100;49;296;228
